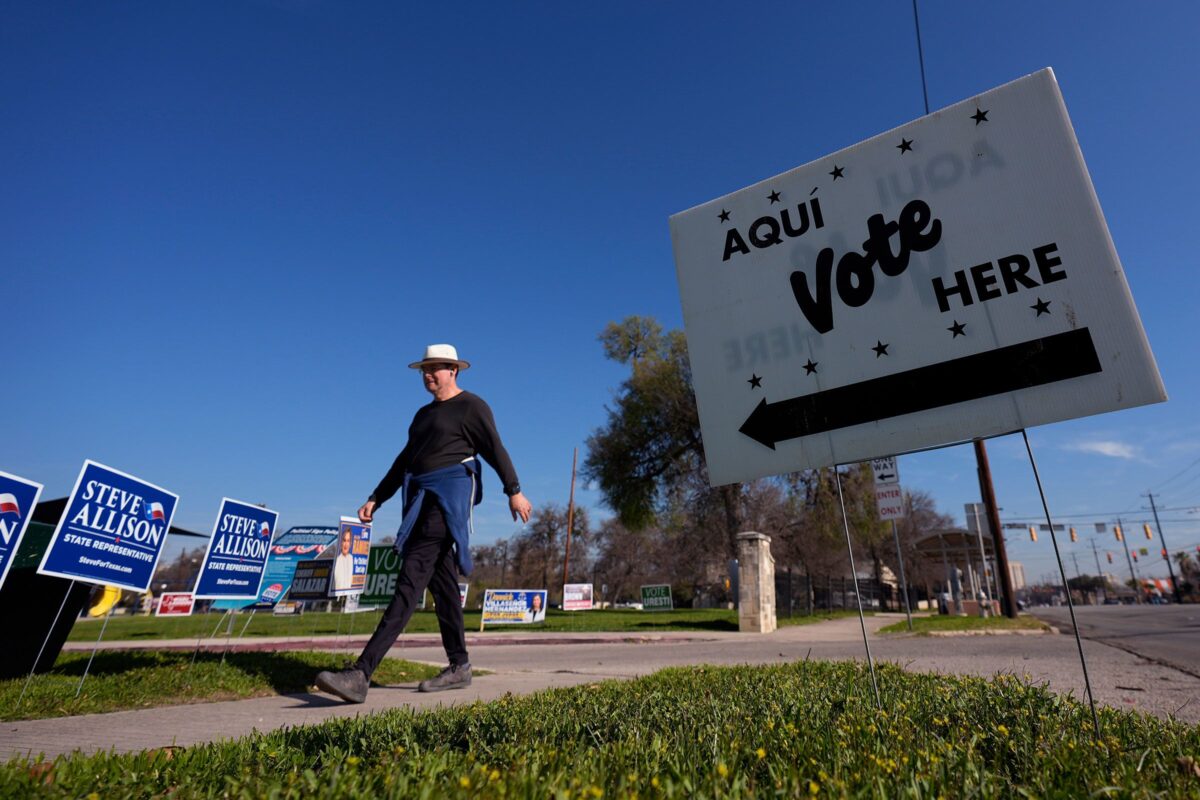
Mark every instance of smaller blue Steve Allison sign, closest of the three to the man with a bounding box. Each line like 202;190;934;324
196;498;280;600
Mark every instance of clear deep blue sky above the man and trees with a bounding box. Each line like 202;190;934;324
0;0;1200;578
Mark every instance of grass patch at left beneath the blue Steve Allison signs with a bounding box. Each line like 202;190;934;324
0;650;438;721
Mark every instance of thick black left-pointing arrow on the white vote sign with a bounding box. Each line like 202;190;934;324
738;327;1100;450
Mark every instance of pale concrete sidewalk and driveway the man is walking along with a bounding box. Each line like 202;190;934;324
0;614;1200;758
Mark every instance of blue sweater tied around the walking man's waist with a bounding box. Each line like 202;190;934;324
396;458;484;575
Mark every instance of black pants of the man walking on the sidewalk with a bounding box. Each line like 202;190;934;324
354;495;469;678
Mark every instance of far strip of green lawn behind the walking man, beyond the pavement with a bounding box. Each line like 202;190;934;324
67;608;873;642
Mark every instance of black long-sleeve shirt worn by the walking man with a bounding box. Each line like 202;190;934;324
371;391;521;507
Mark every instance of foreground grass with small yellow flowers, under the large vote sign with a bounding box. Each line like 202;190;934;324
0;662;1200;799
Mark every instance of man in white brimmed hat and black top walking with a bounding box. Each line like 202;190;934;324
317;344;533;703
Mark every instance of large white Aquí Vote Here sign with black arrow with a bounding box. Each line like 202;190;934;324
671;70;1166;485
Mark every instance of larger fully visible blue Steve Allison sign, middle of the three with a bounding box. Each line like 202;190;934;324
37;461;179;591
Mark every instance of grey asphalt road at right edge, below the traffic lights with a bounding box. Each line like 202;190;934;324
1031;604;1200;678
